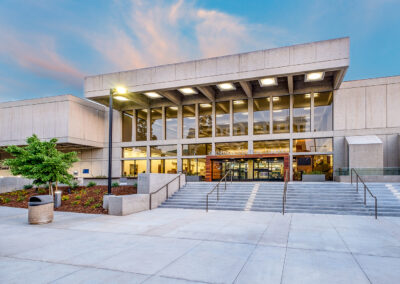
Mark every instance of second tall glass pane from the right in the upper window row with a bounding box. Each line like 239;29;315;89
293;94;311;132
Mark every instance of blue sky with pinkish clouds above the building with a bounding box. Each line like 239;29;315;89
0;0;400;102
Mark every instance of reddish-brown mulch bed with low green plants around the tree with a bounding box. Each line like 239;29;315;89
0;185;137;214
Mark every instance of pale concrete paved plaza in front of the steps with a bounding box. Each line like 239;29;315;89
0;207;400;284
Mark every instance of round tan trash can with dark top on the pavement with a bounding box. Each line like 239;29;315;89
28;195;54;224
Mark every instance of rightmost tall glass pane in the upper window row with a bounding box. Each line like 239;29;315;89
314;92;333;131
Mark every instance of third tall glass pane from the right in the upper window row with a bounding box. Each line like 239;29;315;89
272;96;290;133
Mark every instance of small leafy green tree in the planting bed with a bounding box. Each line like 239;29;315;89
4;134;79;195
